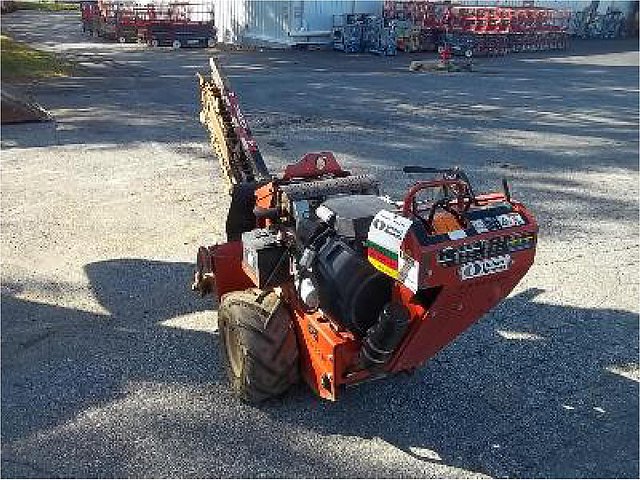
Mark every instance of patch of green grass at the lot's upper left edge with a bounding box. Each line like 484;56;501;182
0;35;72;80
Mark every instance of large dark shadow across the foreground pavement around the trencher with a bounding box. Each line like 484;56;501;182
2;259;638;478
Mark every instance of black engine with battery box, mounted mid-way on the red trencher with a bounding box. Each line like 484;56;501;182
242;195;409;369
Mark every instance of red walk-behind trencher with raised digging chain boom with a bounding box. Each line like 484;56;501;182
192;59;538;402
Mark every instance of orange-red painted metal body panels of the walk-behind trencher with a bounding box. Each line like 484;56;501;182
211;157;538;400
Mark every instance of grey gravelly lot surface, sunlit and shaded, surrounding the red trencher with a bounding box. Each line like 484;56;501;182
1;12;639;478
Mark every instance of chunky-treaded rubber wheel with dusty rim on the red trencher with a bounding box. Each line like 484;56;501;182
218;289;299;403
